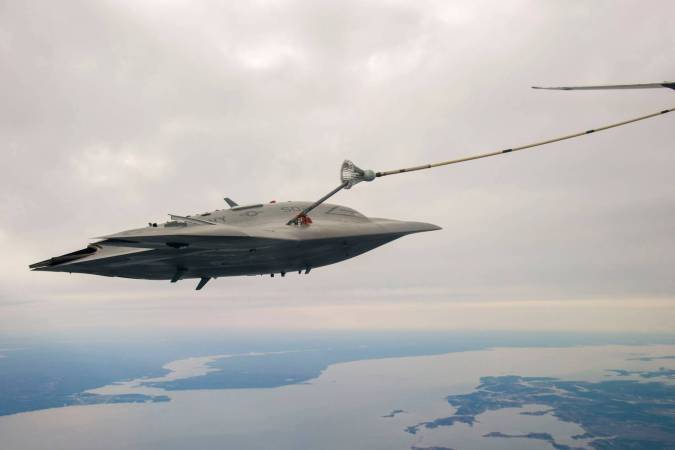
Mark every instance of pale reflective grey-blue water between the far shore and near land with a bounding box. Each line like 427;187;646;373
0;345;675;450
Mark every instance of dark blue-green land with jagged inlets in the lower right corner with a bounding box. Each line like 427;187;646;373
406;376;675;450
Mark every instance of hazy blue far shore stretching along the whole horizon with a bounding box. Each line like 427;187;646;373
0;332;675;420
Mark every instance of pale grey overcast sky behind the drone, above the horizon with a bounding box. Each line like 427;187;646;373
0;0;675;332
